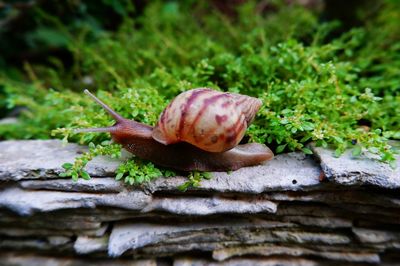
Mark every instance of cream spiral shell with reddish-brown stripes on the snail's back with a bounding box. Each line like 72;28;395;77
152;88;262;152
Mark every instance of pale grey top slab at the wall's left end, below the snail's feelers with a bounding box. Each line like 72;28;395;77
0;140;128;180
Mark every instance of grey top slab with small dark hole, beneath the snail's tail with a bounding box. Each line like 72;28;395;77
147;153;321;194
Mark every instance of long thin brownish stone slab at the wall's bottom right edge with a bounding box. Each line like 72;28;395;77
213;244;380;264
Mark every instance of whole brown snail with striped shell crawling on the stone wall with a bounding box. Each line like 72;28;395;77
75;88;274;171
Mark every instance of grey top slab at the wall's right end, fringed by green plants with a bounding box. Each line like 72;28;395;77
312;142;400;189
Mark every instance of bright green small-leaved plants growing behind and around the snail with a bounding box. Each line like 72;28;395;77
0;0;400;184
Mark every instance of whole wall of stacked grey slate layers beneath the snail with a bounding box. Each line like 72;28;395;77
0;140;400;265
